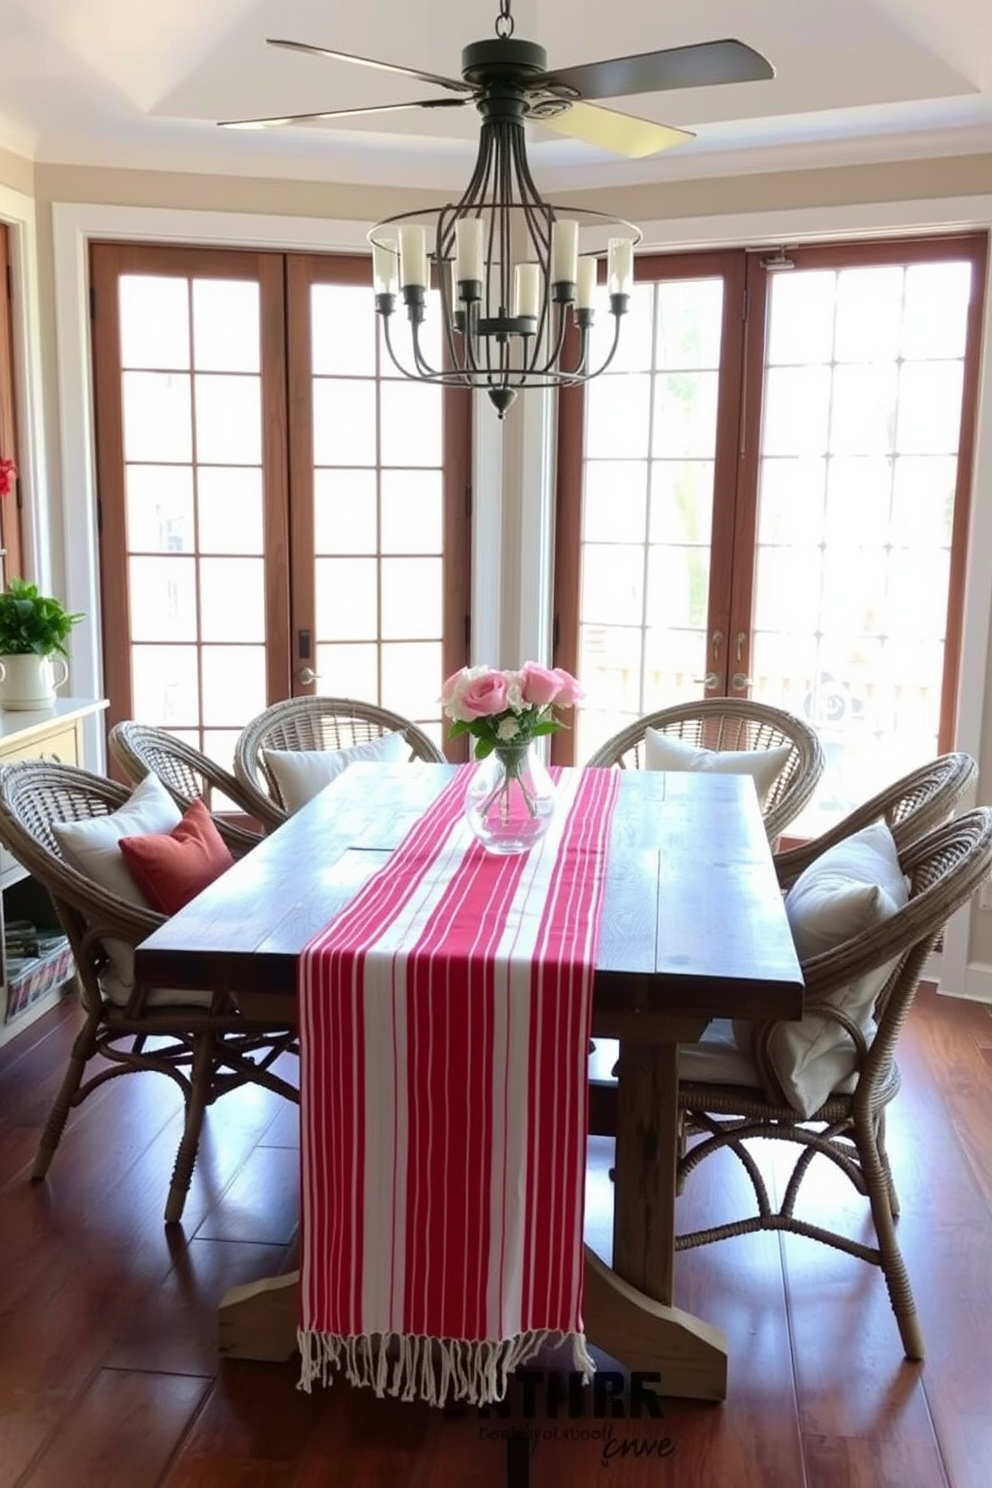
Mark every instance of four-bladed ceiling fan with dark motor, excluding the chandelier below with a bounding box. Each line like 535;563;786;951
222;0;775;158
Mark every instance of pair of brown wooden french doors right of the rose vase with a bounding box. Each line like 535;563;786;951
555;235;988;830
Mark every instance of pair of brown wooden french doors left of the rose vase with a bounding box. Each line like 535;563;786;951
91;244;468;763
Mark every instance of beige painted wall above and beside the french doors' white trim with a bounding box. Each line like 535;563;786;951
11;150;992;967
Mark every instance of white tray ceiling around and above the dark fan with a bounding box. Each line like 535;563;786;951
0;0;992;189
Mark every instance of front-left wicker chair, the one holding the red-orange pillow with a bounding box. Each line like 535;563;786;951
0;760;299;1223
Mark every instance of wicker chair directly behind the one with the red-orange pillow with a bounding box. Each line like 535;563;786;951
107;719;262;856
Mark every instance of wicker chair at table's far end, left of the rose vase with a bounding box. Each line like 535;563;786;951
233;696;445;829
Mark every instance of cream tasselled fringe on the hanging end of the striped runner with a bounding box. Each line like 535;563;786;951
297;1327;596;1406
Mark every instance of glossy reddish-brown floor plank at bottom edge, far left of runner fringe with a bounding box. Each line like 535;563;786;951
16;1369;210;1488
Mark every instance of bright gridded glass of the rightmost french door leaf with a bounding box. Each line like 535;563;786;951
751;262;971;835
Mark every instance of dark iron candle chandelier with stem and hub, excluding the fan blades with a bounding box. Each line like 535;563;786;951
369;0;648;418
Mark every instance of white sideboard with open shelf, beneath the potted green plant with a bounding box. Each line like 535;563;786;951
0;698;107;1045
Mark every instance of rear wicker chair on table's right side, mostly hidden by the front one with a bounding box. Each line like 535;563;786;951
775;751;979;888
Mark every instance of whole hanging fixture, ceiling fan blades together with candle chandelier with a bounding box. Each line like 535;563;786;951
222;0;775;418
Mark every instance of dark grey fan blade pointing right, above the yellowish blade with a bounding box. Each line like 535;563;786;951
529;40;775;98
